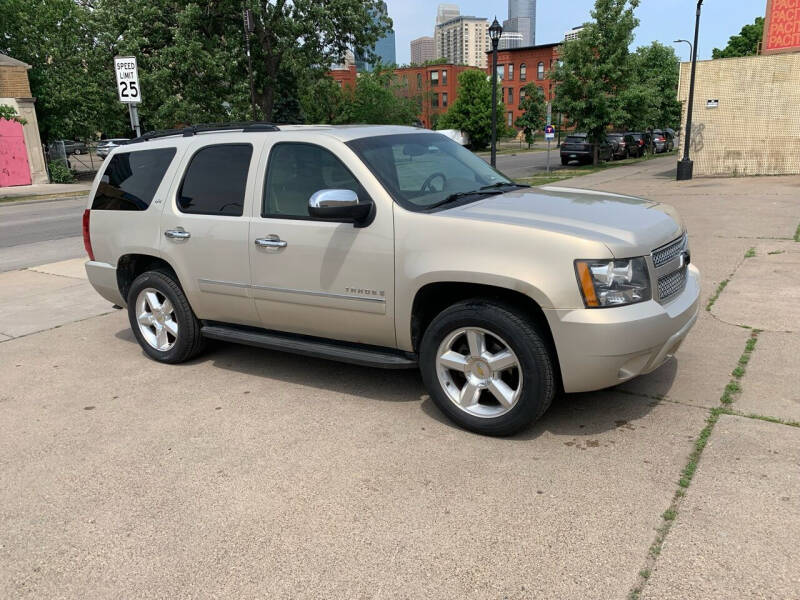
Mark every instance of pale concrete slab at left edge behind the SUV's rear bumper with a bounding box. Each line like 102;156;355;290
0;258;112;341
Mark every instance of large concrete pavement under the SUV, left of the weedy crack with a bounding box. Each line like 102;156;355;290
0;312;705;599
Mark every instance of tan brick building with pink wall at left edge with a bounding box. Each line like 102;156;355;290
0;54;48;187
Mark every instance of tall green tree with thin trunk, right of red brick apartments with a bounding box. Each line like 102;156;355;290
550;0;639;164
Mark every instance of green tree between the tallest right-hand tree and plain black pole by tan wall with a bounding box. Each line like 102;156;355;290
615;42;681;129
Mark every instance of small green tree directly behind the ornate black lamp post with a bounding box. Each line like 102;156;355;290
438;69;513;149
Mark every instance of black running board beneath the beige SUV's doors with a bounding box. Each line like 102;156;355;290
200;323;417;369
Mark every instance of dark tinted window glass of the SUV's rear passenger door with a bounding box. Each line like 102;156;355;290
178;144;253;217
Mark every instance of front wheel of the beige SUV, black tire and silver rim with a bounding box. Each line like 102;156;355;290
419;299;556;436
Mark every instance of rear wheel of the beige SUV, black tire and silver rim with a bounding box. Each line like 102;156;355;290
128;269;205;364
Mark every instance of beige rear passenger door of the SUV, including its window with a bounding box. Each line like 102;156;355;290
161;135;261;325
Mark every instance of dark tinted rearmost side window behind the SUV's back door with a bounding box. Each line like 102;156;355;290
92;148;175;210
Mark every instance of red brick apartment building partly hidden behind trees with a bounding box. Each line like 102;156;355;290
328;44;560;127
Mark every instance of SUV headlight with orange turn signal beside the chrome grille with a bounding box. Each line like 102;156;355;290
575;257;651;308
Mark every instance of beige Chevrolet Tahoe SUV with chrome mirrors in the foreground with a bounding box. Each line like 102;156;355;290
83;124;700;435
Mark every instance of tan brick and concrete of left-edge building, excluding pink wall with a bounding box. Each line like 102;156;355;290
0;54;49;185
